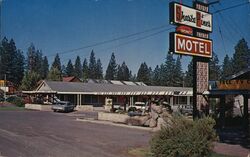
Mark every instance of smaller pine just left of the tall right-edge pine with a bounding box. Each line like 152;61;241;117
221;55;233;79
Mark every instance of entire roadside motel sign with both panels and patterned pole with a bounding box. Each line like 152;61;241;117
169;0;213;119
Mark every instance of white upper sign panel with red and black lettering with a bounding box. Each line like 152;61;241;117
169;2;212;32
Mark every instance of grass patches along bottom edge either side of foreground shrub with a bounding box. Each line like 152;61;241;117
128;148;233;157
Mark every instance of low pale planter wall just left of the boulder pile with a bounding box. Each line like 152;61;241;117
98;112;129;124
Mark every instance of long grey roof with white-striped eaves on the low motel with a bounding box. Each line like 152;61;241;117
28;81;192;96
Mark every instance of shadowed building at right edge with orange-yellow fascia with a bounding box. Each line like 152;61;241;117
203;67;250;129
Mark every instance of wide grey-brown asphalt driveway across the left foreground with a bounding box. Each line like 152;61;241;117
0;111;151;157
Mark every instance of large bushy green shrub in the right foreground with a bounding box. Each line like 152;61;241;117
150;117;217;157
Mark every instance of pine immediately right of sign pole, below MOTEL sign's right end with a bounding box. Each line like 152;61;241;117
209;53;221;80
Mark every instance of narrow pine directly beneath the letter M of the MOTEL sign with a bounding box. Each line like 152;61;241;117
173;56;183;87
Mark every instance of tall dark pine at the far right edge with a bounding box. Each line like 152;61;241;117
232;39;250;73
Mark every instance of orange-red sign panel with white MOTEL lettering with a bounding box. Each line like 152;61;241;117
170;32;212;58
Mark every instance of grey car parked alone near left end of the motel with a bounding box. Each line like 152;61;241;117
51;101;75;112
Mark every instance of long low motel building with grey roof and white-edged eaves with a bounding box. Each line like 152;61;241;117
23;80;193;110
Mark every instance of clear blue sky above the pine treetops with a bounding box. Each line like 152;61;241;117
2;0;250;73
